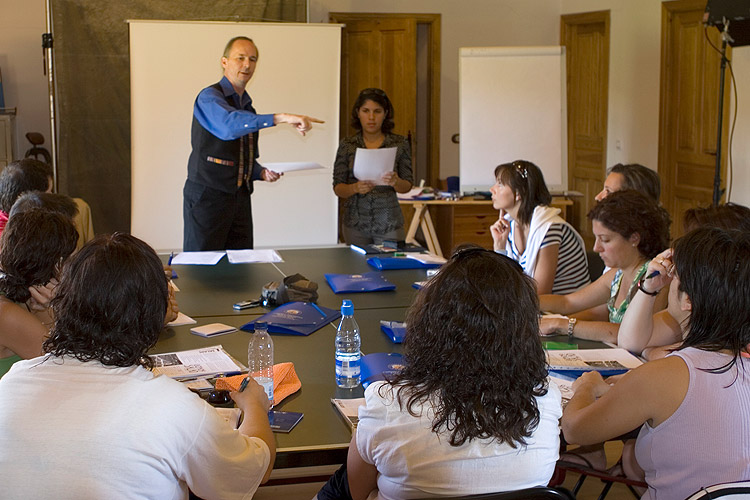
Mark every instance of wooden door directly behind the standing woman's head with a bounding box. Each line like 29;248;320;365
332;15;417;150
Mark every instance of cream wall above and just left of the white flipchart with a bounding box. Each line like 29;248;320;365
309;0;564;178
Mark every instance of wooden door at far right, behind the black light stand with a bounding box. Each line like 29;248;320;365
659;0;729;237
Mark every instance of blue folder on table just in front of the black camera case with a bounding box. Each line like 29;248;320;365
240;302;341;335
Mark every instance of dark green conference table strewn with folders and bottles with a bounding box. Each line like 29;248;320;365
150;246;602;469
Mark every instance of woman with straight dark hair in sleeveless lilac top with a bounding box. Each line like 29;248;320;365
562;227;750;499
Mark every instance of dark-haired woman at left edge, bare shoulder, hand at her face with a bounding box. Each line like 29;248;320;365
0;209;78;377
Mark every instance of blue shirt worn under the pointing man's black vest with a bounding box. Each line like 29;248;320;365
193;76;273;141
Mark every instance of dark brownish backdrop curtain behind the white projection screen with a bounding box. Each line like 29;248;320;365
49;0;307;233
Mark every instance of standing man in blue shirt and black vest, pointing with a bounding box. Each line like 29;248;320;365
182;36;323;251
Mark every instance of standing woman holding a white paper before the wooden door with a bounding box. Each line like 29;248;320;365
333;88;413;245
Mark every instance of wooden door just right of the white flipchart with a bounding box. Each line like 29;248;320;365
560;11;609;248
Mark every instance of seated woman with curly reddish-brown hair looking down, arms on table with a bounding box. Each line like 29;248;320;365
539;190;670;342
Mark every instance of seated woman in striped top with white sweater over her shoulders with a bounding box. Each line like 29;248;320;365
490;160;591;294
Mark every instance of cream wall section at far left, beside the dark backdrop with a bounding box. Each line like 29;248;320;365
0;0;50;158
